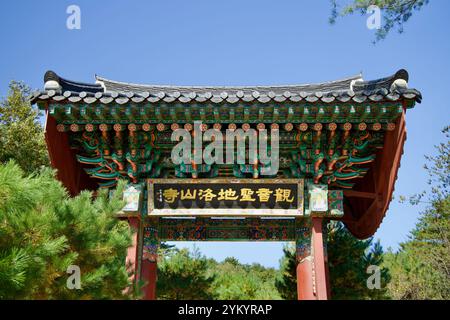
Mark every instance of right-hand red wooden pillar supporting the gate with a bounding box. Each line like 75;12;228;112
296;218;328;300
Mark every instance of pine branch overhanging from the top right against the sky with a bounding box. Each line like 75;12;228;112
330;0;429;41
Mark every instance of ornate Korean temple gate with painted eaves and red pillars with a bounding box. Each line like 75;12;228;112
32;70;421;299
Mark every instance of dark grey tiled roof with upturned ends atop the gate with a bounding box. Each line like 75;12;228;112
31;70;422;104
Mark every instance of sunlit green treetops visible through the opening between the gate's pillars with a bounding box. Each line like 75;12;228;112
157;248;281;300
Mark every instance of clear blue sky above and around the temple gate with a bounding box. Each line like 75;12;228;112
0;0;450;267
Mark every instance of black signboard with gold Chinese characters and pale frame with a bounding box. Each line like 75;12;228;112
148;179;303;216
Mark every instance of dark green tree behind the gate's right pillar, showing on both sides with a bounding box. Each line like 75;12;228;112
276;222;390;300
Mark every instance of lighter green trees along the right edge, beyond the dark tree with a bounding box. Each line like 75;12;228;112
385;127;450;300
